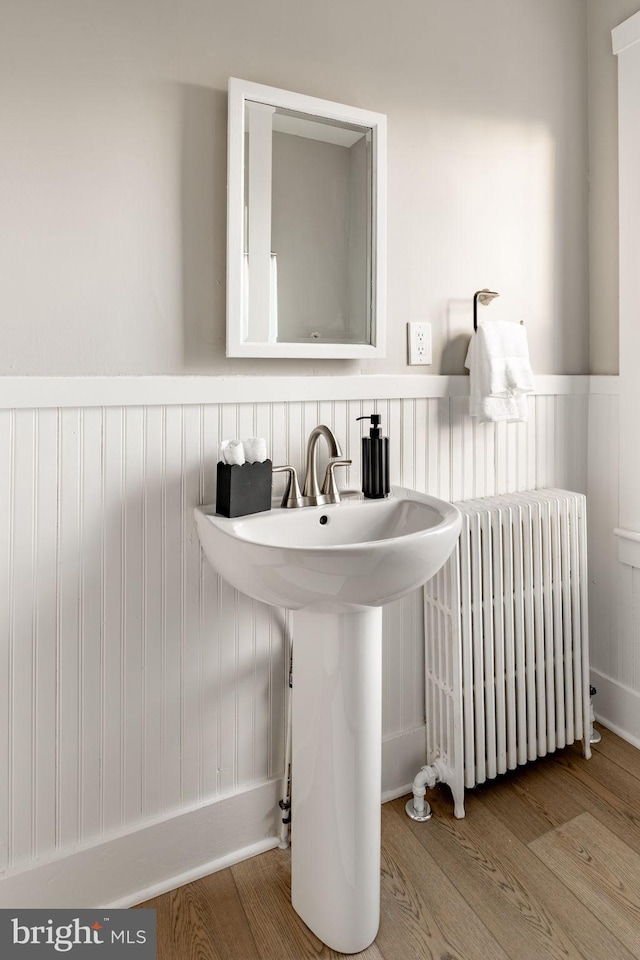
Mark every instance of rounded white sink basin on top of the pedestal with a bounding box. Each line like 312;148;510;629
195;487;460;612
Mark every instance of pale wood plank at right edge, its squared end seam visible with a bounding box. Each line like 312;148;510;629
529;813;640;958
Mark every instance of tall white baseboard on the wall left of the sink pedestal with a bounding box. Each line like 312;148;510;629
0;780;281;908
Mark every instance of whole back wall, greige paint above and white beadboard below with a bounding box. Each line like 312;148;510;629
0;0;628;906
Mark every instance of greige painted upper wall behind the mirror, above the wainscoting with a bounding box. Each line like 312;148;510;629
0;0;588;375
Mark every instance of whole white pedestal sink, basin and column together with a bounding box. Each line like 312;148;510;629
195;487;461;953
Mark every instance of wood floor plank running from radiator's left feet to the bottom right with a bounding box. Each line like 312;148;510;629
396;791;634;960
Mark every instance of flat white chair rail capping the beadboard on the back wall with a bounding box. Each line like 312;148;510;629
0;374;600;410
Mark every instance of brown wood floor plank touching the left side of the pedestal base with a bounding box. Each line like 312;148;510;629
231;849;384;960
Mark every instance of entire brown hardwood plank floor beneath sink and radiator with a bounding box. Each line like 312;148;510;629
140;730;640;960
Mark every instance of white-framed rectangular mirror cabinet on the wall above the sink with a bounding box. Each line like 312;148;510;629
227;77;386;359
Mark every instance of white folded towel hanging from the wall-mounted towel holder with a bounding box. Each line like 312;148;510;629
465;320;534;422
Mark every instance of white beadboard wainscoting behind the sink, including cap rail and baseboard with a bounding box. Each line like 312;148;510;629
0;376;612;906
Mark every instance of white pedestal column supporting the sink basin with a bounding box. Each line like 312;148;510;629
291;607;382;953
